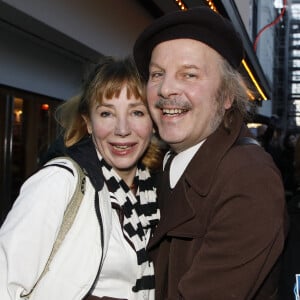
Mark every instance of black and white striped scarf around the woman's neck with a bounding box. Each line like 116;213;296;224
100;157;160;299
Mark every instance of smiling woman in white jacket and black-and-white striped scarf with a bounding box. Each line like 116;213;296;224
0;57;160;300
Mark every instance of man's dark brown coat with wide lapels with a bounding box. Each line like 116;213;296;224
149;116;286;300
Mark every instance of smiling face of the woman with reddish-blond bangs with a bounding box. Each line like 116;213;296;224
85;86;153;179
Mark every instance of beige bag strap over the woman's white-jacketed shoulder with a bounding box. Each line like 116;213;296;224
21;157;86;299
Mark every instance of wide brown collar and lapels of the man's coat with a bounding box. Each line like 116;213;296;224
148;111;246;249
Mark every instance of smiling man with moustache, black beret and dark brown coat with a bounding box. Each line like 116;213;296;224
134;7;285;300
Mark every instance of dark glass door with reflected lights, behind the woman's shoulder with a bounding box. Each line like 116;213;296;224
0;86;61;224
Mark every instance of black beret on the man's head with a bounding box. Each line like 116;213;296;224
133;6;244;79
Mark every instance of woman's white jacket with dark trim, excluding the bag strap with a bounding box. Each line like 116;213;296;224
0;159;111;300
